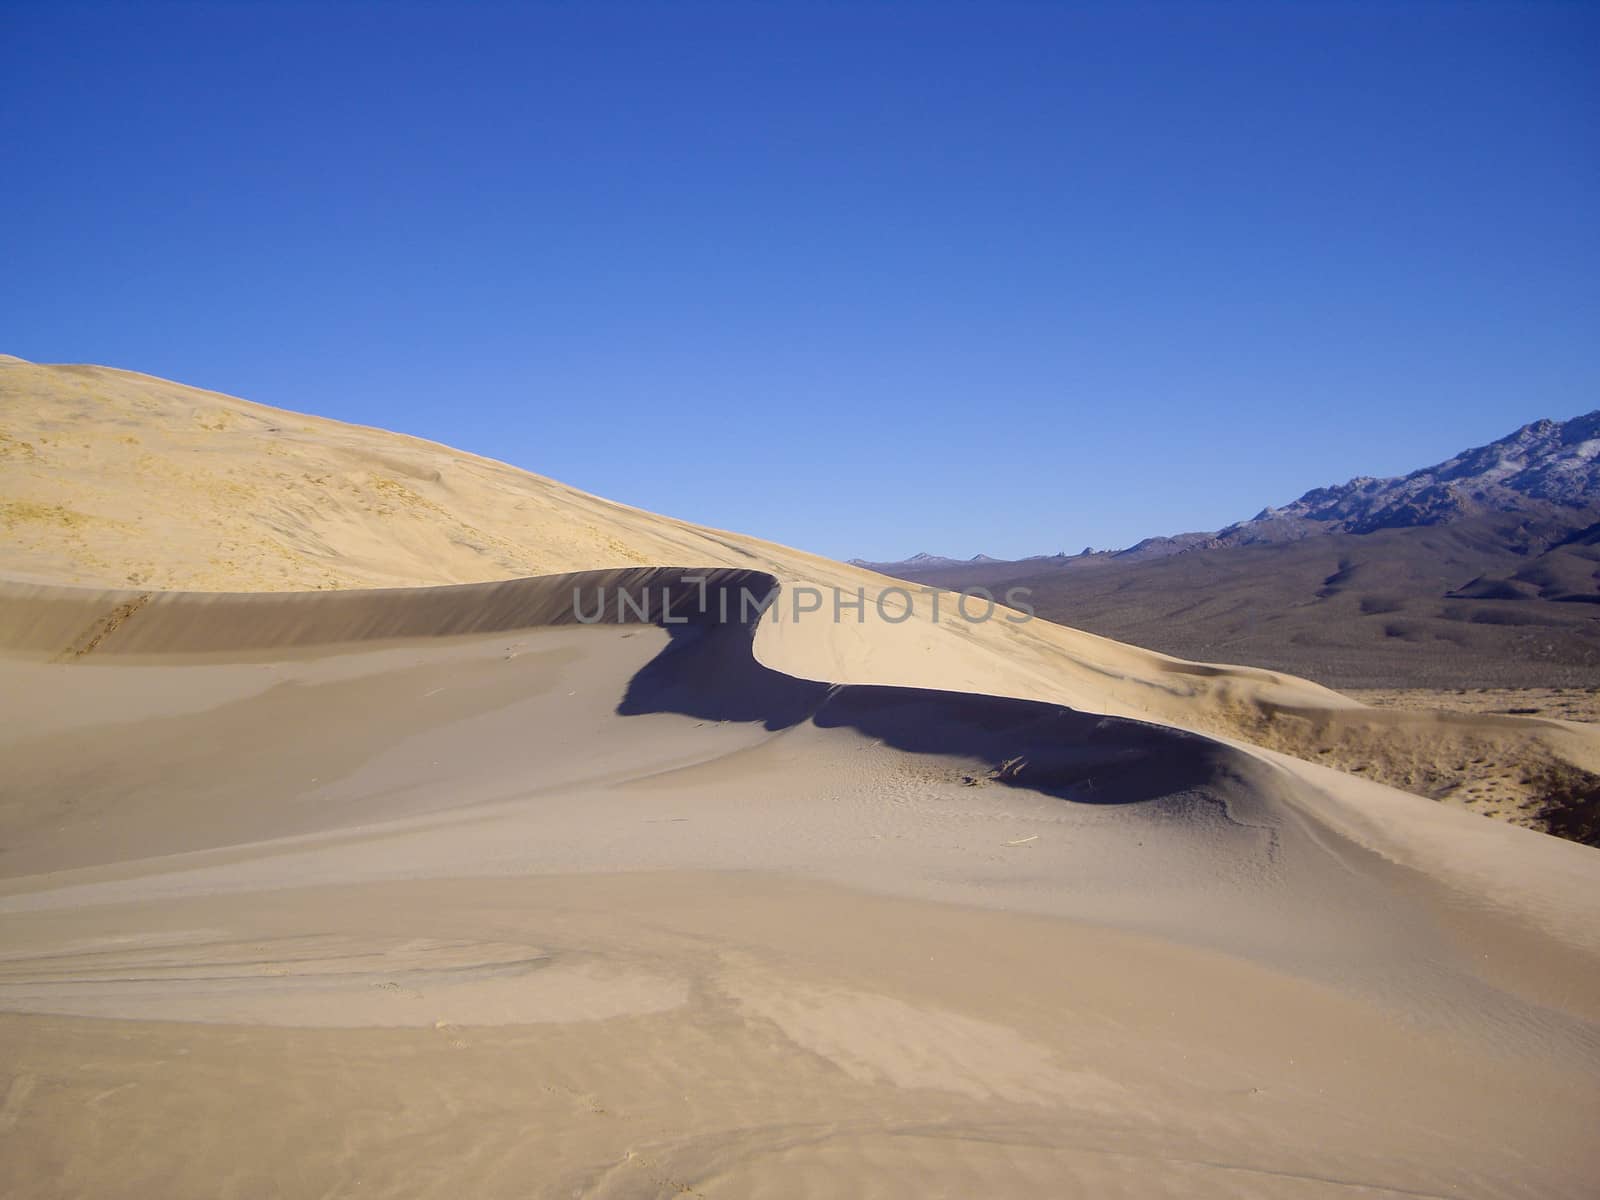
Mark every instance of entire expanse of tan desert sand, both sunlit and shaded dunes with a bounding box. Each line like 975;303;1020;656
9;362;1600;1197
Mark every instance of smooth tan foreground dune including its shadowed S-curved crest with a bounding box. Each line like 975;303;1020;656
0;570;1600;1195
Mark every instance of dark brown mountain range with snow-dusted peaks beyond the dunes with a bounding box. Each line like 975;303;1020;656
861;411;1600;688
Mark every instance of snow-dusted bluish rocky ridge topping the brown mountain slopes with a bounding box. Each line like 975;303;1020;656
851;410;1600;568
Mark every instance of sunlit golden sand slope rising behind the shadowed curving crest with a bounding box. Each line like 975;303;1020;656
0;357;1600;826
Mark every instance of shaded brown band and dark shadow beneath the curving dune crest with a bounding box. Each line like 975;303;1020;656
0;568;1264;870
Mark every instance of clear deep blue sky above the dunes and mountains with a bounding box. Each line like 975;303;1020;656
0;0;1600;558
